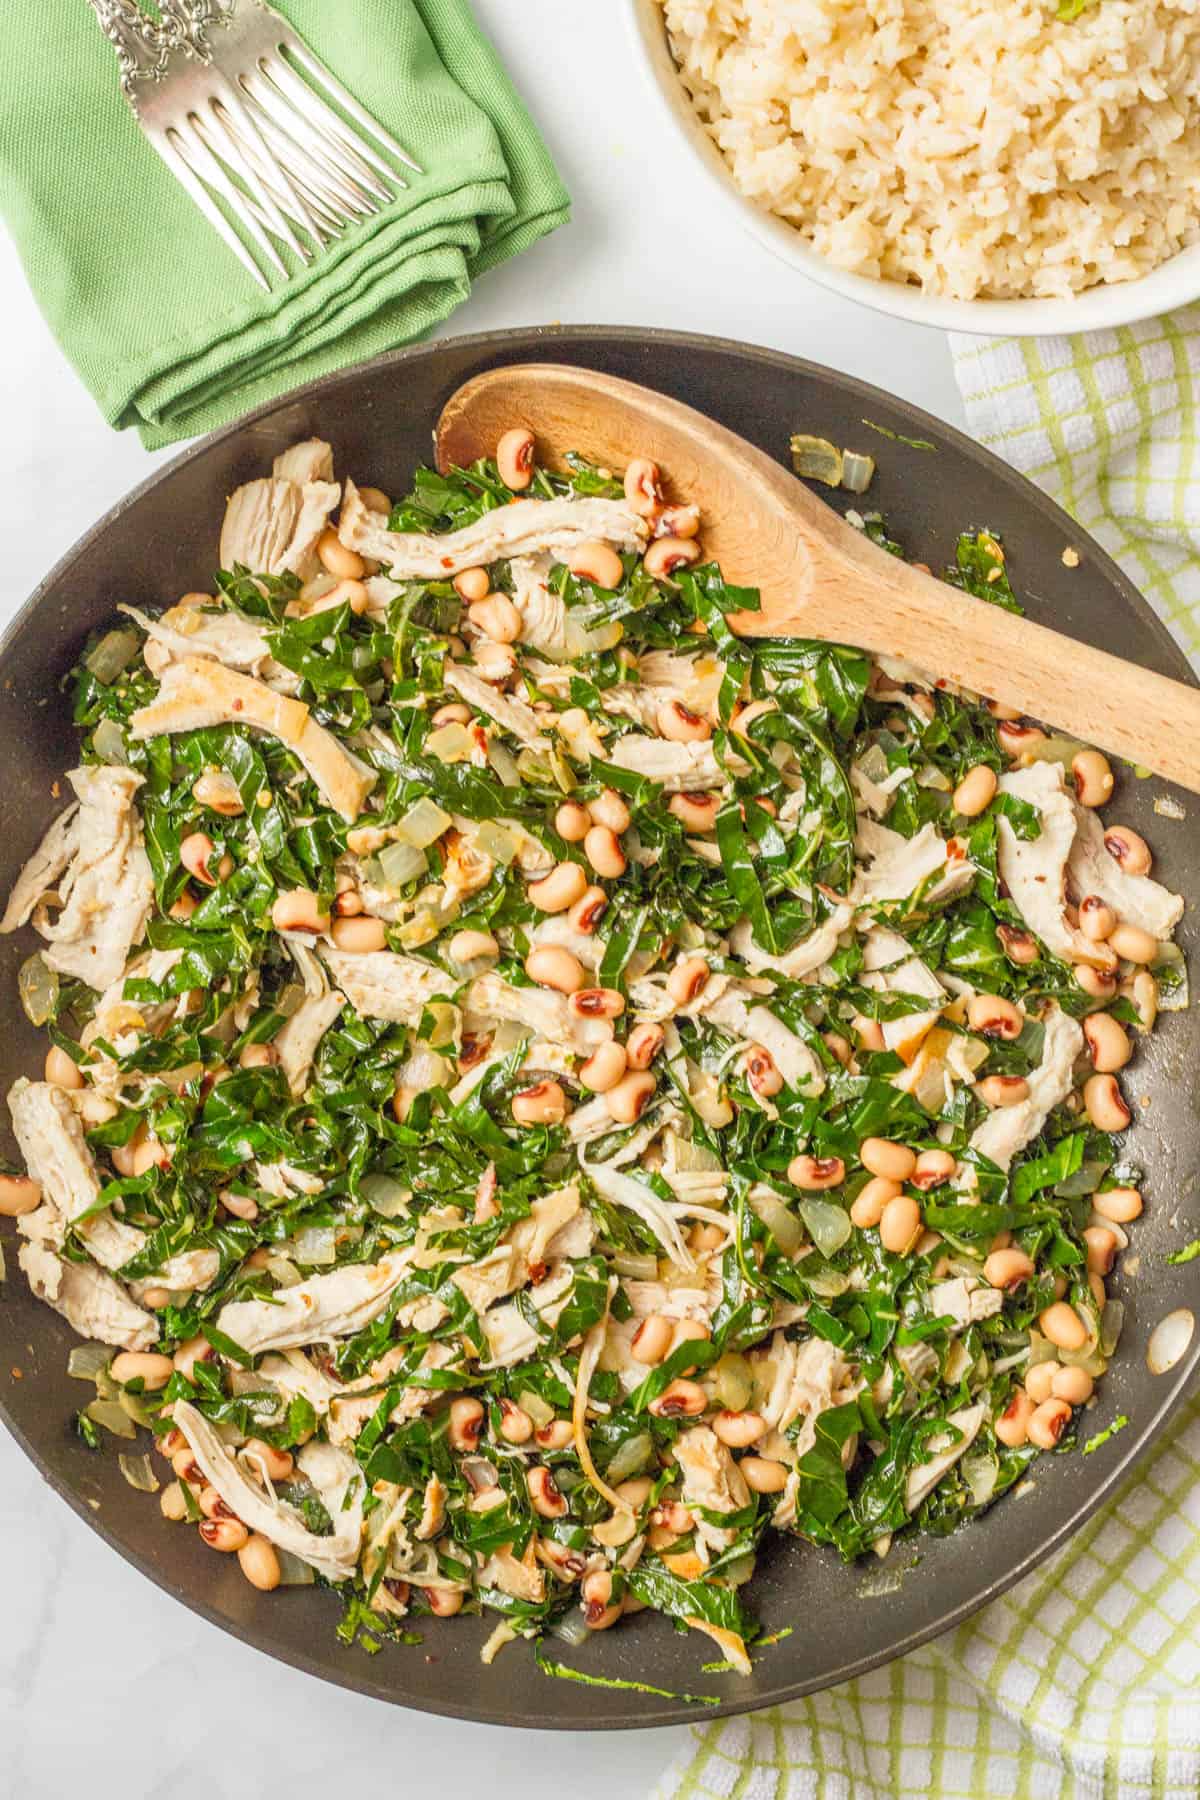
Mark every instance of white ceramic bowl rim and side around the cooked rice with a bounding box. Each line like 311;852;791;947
624;0;1200;337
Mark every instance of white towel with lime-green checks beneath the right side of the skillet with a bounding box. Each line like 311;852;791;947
655;306;1200;1800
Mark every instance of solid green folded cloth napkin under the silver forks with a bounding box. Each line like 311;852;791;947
0;0;569;448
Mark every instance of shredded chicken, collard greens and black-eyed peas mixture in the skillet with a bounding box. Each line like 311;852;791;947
0;428;1184;1672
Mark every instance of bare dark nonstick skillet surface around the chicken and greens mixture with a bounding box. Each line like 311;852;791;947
0;328;1200;1730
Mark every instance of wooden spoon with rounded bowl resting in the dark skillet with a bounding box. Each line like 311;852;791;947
437;364;1200;792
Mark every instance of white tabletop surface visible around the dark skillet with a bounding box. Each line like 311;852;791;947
0;0;963;1800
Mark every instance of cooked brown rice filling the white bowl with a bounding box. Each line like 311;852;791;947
662;0;1200;299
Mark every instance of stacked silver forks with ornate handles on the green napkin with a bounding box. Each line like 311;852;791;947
88;0;423;292
